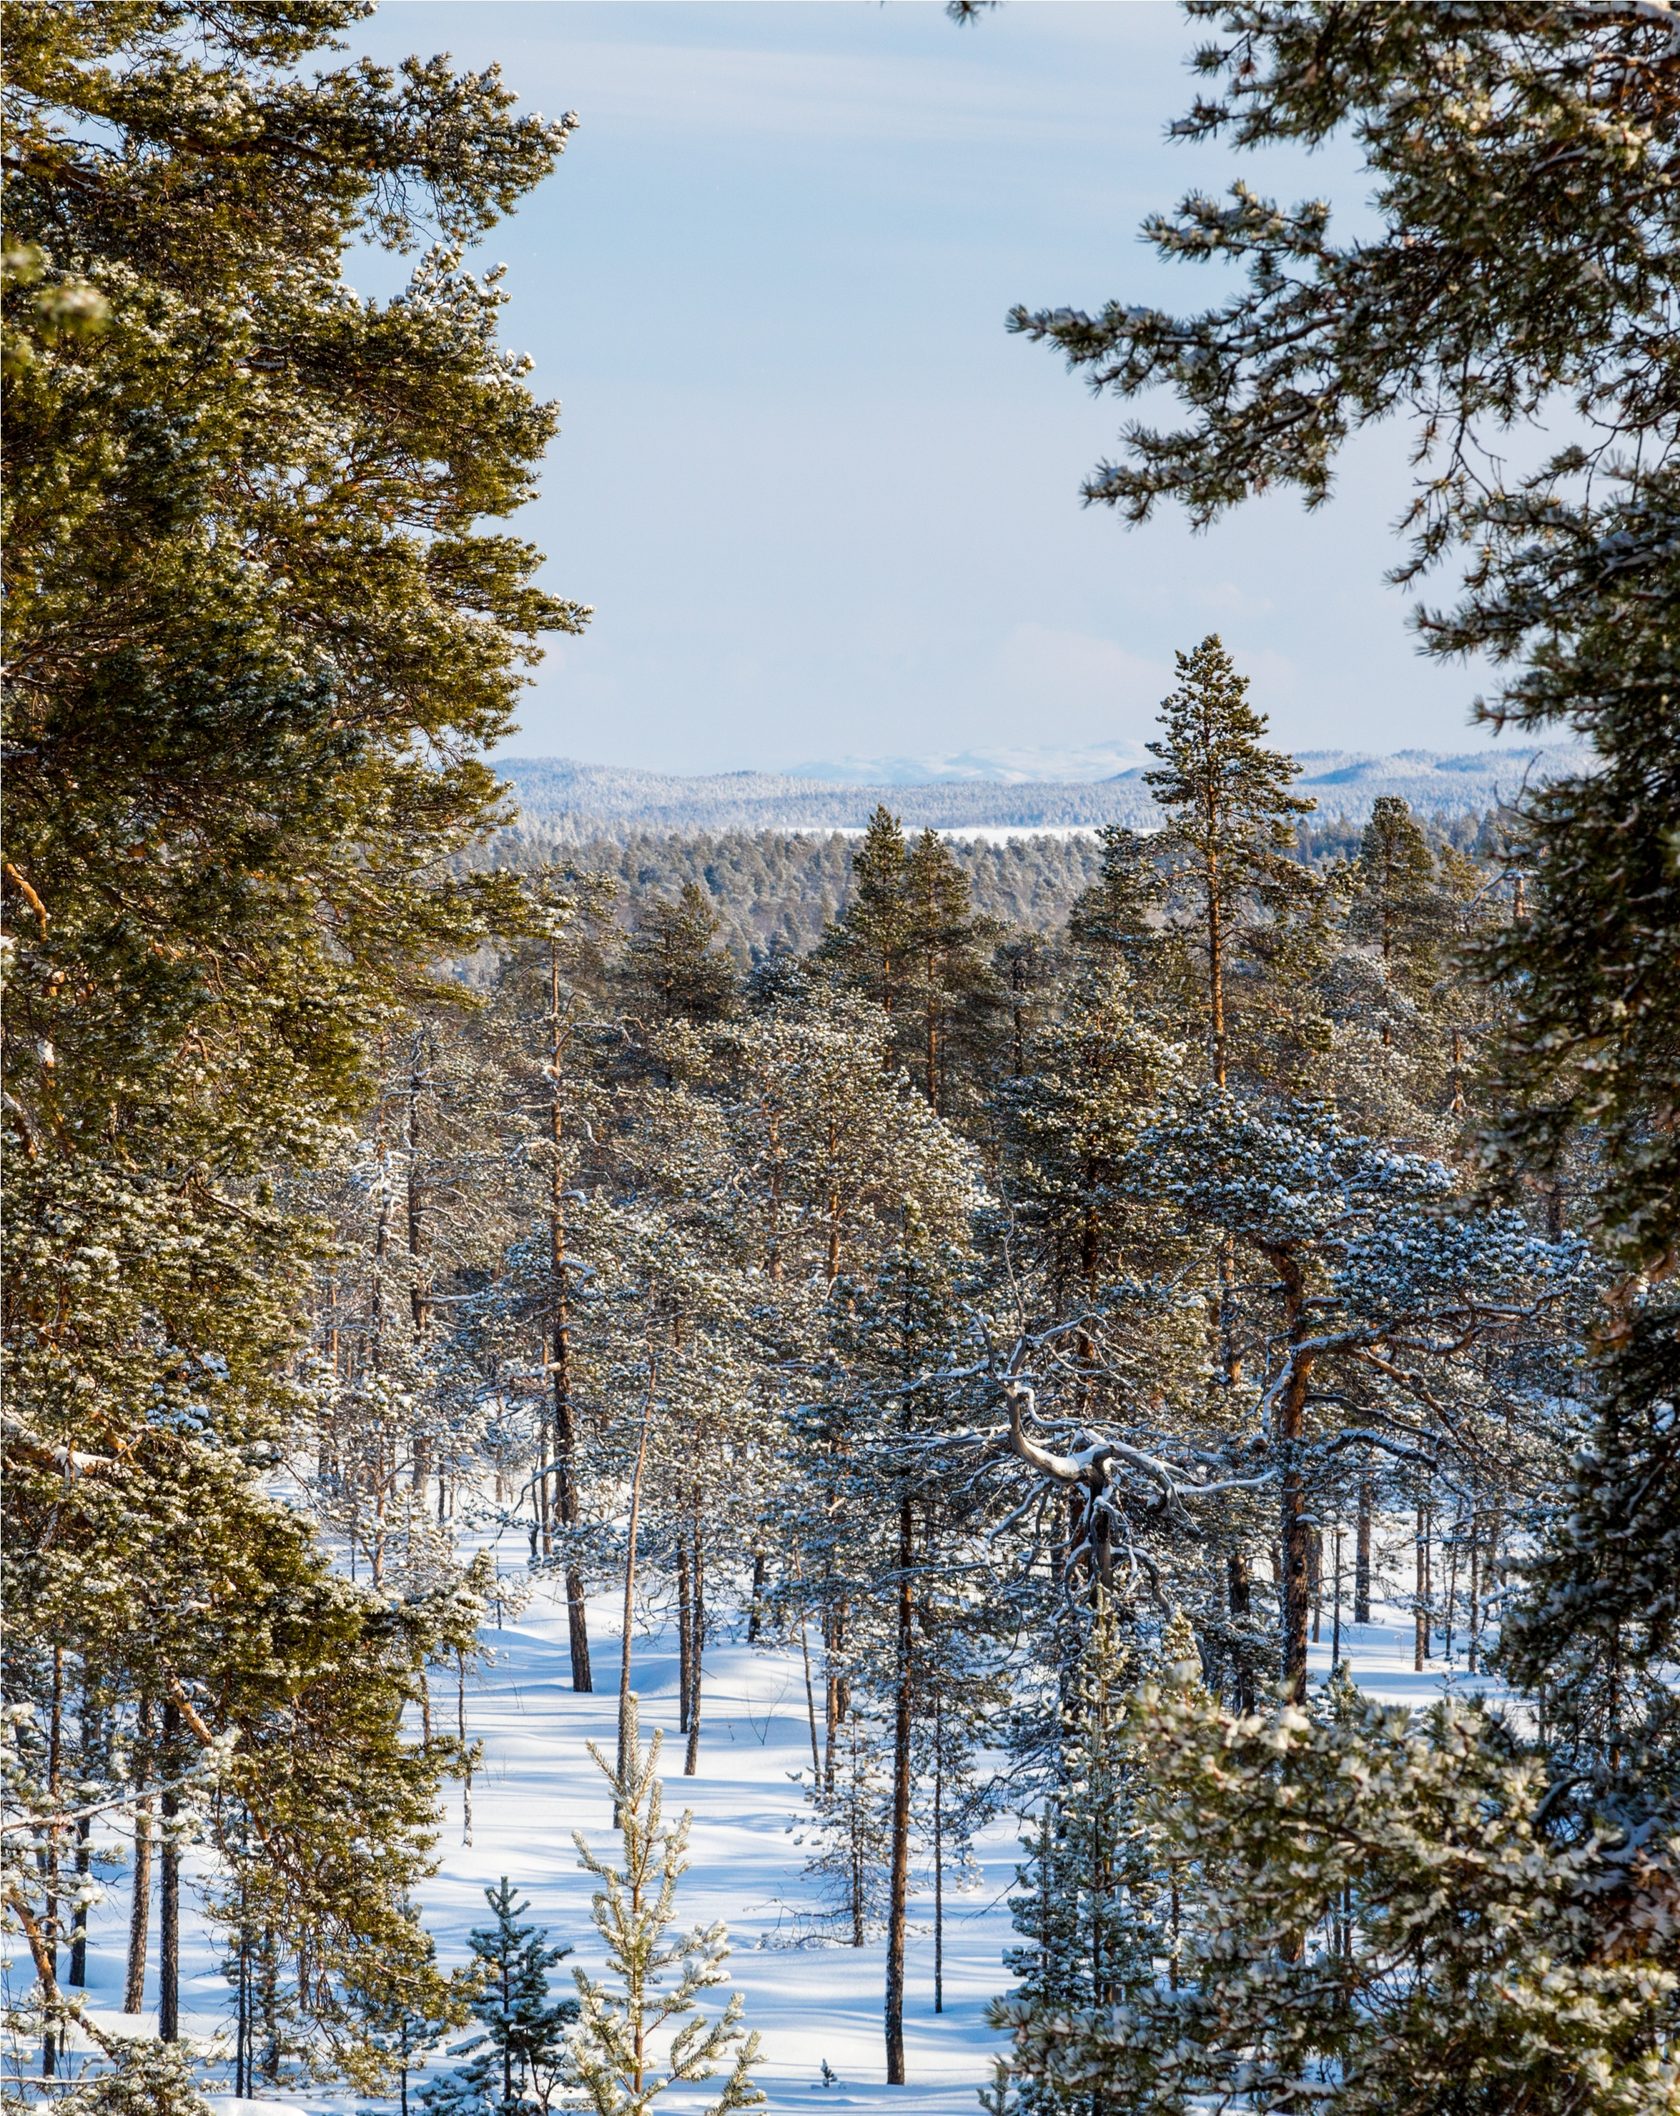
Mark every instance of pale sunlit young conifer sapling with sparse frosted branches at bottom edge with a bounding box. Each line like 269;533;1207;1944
571;1699;764;2116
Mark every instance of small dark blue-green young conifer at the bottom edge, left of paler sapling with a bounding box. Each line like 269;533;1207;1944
421;1873;578;2116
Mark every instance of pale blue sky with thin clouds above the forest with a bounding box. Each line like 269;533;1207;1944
355;0;1483;770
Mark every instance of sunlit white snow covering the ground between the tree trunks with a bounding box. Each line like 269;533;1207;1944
52;1545;1481;2116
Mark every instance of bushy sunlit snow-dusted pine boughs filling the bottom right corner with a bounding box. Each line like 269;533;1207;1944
1003;1680;1680;2116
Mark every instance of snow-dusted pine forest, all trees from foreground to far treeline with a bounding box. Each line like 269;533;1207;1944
0;0;1680;2116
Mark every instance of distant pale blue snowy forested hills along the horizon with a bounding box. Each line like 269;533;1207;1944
497;745;1587;842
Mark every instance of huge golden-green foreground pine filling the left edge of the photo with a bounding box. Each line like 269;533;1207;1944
4;0;584;2069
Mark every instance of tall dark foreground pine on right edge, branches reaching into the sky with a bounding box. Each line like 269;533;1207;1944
1014;0;1680;1870
